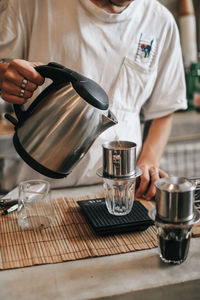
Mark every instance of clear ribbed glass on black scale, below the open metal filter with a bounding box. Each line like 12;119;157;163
103;178;136;216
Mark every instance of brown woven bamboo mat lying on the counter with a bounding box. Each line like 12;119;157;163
0;195;200;270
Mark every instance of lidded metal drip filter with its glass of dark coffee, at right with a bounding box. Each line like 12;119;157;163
149;177;200;264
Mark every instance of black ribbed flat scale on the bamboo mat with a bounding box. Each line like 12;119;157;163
77;198;154;234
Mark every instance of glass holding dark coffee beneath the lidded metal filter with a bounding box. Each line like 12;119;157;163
155;222;193;264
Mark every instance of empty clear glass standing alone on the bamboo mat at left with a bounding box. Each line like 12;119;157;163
18;180;54;229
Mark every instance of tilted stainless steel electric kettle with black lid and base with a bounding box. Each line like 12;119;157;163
5;63;117;178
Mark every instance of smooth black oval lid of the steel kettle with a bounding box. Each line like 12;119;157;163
72;75;109;110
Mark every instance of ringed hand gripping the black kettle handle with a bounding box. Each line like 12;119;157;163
0;59;44;104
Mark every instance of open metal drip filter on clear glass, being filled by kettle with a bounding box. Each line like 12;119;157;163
97;140;142;216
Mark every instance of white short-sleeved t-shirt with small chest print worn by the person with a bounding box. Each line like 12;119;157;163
0;0;187;186
